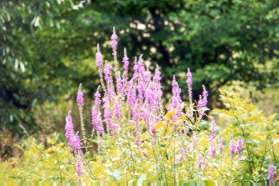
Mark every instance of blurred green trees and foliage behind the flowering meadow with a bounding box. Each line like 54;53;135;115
0;0;279;149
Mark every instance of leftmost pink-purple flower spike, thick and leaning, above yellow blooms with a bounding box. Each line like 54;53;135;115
65;111;81;152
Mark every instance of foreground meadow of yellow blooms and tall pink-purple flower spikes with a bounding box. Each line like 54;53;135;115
0;30;279;186
